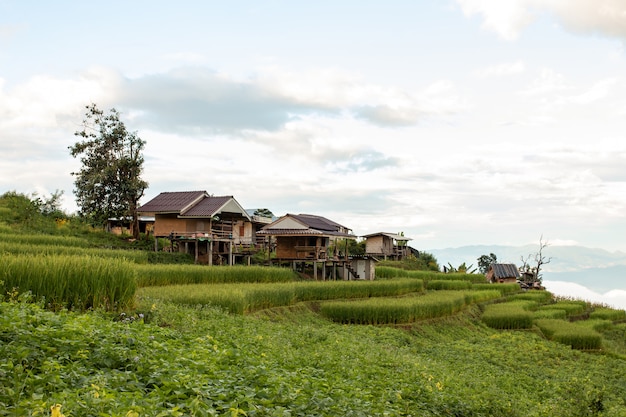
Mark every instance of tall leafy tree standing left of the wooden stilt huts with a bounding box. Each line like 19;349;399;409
69;104;148;238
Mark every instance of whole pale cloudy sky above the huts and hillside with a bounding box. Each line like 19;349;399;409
0;0;626;251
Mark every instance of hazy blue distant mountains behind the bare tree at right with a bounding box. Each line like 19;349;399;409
425;245;626;292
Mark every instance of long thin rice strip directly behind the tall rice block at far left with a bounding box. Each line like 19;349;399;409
0;241;148;264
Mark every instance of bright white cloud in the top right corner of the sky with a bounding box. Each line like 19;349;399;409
457;0;626;40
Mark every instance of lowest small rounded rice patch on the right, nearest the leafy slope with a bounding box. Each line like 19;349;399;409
535;319;602;350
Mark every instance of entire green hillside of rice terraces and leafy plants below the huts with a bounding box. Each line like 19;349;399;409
0;195;626;417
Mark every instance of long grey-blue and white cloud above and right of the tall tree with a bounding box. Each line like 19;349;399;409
119;67;464;134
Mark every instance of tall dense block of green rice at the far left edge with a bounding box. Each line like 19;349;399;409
0;255;136;310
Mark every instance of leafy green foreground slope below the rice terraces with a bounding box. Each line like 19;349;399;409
0;300;626;416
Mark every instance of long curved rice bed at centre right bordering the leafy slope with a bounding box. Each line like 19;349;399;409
320;291;466;324
